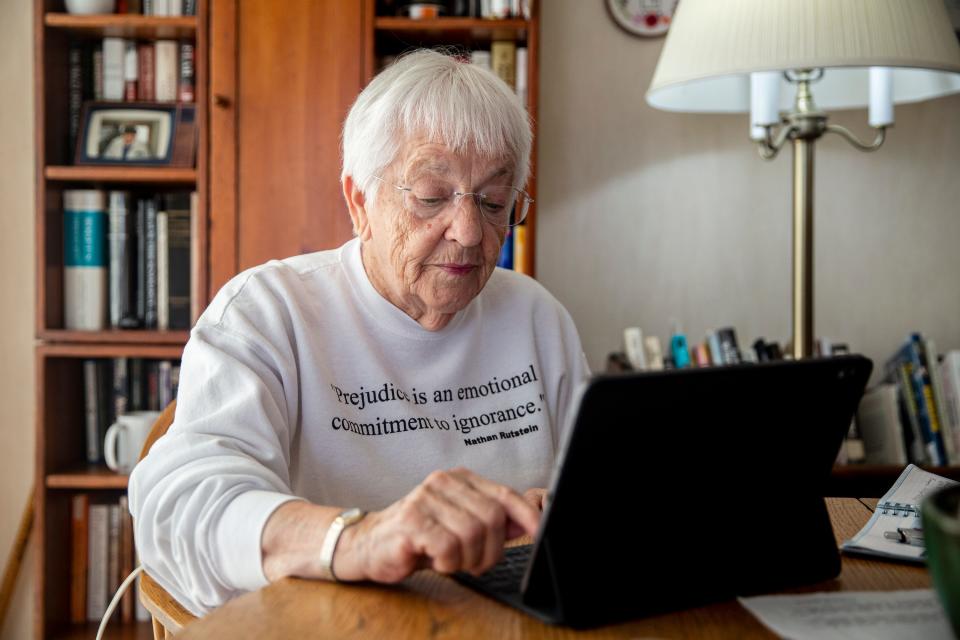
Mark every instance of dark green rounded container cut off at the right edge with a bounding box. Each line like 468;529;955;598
920;486;960;638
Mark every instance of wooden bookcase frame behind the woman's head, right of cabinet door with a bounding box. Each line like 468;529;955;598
363;0;540;276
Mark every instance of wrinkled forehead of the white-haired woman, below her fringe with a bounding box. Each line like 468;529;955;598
393;138;514;179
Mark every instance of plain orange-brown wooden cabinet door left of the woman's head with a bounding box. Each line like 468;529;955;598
233;0;363;270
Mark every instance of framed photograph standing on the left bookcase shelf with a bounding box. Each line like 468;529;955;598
75;102;197;167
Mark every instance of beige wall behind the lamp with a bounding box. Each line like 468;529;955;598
537;0;960;380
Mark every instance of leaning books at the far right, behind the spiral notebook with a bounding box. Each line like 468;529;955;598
857;333;960;466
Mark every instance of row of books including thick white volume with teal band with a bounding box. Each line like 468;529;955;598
63;189;198;331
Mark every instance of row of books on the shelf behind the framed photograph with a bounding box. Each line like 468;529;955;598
67;37;196;154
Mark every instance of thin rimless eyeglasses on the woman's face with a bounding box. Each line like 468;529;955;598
374;176;533;227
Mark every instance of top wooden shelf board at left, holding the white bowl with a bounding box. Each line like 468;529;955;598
43;13;197;40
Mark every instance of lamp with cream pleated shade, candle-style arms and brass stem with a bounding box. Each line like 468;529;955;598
647;0;960;359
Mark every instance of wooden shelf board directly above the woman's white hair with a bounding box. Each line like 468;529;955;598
373;17;530;43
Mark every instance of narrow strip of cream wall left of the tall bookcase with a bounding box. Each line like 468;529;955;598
0;0;35;639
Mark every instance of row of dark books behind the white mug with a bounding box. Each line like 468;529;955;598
83;358;180;464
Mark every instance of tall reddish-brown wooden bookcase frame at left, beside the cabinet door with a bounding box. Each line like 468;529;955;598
33;0;209;639
